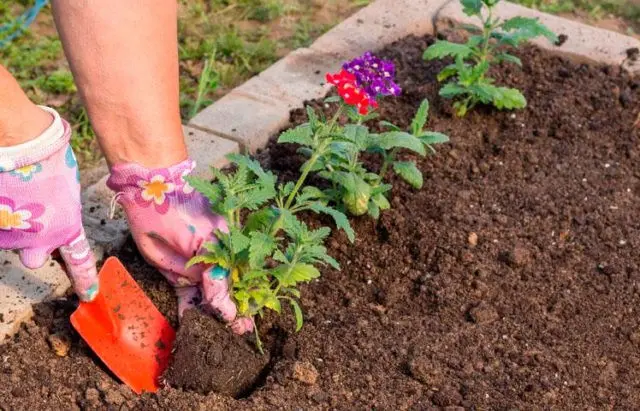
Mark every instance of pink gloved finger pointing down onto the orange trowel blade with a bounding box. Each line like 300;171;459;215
60;229;100;301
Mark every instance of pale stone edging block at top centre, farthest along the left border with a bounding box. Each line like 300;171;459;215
311;0;448;60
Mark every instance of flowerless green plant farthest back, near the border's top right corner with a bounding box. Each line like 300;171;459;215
424;0;558;117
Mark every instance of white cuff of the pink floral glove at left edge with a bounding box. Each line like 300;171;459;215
0;106;71;172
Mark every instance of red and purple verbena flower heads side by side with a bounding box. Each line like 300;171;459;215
327;52;401;115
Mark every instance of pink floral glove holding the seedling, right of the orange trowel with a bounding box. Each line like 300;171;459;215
107;160;253;334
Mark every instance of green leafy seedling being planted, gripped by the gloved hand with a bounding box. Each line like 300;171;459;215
188;154;354;352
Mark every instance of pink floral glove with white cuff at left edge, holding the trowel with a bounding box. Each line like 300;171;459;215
0;107;99;301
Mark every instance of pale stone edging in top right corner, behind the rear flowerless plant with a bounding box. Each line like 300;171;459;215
436;0;640;72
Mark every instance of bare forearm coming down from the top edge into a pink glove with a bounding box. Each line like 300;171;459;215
52;0;187;167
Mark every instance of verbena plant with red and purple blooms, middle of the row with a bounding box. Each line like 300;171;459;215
278;53;449;218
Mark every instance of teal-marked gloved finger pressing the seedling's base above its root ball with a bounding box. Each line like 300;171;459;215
202;266;238;322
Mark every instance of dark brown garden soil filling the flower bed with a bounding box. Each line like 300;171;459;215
0;33;640;410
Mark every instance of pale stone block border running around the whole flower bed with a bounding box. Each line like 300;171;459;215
0;0;640;344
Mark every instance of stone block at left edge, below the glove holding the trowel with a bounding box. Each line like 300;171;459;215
0;251;71;344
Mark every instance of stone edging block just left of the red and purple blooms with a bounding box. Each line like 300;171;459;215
236;48;342;109
